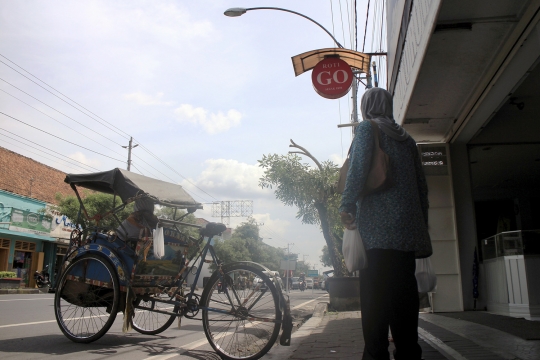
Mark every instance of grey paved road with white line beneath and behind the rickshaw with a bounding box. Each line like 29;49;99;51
0;290;328;360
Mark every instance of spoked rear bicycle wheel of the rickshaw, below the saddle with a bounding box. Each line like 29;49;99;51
200;264;282;360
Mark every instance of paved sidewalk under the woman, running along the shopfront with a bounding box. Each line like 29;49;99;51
263;303;540;360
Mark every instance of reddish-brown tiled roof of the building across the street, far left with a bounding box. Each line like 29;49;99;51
0;146;73;204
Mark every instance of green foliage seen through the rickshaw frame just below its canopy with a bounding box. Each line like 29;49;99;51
55;190;133;229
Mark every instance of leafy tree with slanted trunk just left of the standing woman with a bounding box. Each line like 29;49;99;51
259;140;348;276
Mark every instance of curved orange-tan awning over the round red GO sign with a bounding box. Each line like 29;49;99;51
291;48;371;76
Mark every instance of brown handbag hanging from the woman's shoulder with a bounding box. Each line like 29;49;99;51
336;120;393;196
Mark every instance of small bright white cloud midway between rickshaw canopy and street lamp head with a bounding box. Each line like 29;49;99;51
174;104;242;134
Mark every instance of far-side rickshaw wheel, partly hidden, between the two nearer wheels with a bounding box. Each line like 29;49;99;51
131;293;179;335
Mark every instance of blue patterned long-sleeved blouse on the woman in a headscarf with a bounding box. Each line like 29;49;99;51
339;121;432;258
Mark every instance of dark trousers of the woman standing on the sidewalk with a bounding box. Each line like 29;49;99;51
360;249;422;360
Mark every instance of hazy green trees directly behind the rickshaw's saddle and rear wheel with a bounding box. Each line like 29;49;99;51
214;218;283;271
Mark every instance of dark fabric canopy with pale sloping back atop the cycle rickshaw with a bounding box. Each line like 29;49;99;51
64;168;202;209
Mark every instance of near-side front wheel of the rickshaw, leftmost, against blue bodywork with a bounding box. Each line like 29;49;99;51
54;254;120;343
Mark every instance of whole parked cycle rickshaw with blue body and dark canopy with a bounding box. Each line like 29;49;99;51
54;168;292;359
